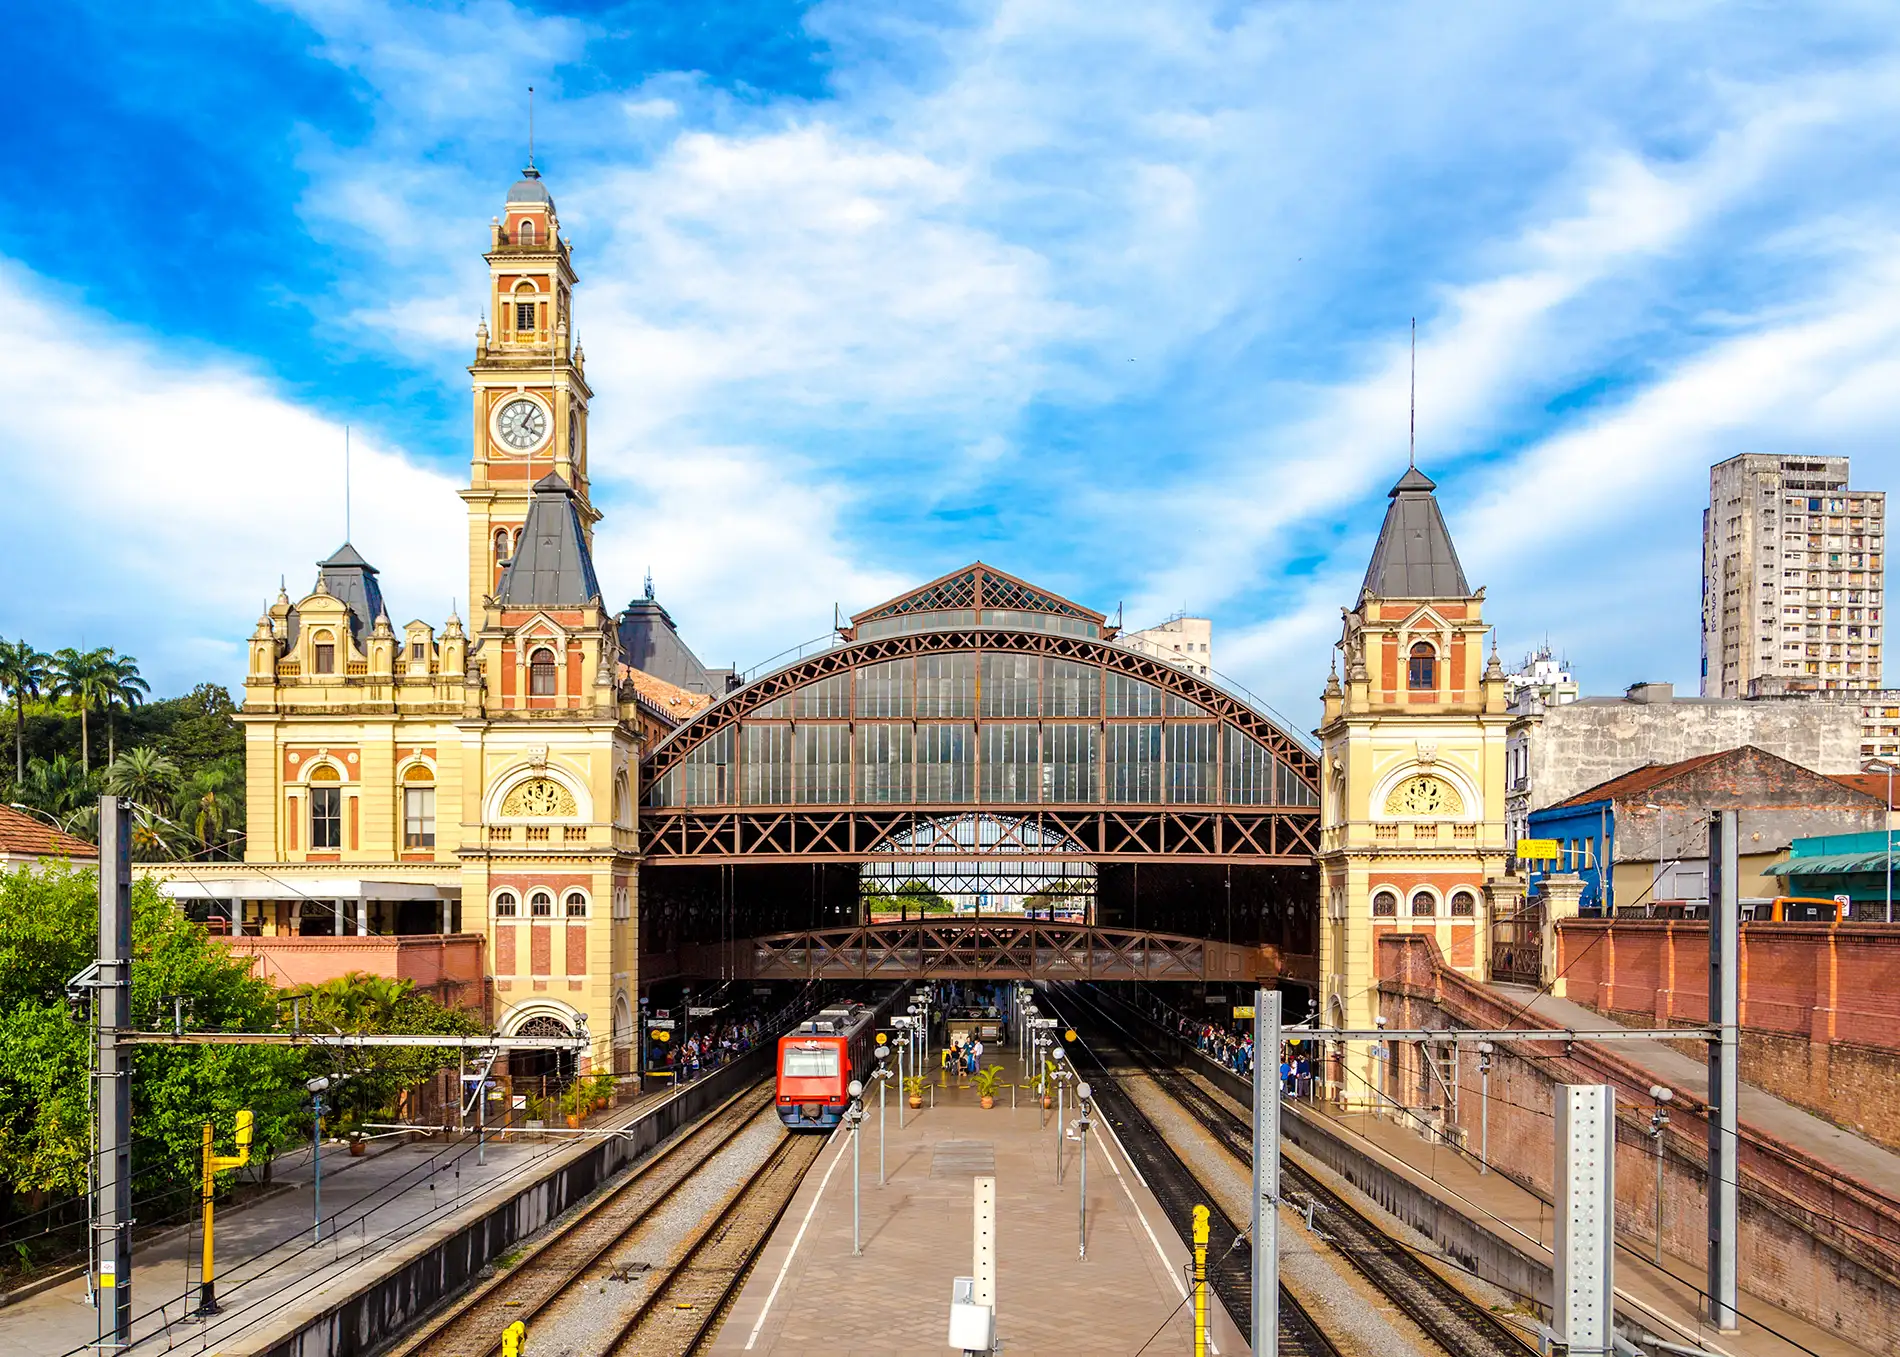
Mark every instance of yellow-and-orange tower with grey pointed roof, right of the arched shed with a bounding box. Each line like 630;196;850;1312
1317;468;1516;1102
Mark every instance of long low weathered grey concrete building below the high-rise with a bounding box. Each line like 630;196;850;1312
1505;682;1862;842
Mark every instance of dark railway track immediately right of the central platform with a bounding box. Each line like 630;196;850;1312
1041;980;1340;1357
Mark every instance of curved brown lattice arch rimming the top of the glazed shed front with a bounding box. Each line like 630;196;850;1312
640;627;1319;806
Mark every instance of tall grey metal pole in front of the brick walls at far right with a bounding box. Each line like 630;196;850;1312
1708;810;1742;1334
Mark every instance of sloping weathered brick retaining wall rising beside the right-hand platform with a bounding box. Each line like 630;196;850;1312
1378;933;1900;1351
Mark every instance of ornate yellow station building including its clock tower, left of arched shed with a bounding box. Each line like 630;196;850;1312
142;165;726;1070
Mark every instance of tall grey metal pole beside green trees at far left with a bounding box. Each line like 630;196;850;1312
91;796;131;1347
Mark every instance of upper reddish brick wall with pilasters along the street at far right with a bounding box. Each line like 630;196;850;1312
1556;920;1900;1148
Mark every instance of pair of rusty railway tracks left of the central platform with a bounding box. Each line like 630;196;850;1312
386;1076;801;1357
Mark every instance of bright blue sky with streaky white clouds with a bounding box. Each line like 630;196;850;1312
11;0;1900;728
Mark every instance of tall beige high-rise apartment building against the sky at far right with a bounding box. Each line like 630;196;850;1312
1702;452;1887;698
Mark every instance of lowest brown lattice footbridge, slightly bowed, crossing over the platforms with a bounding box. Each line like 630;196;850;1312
739;918;1271;981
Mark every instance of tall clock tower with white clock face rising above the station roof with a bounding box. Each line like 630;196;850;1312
462;160;600;627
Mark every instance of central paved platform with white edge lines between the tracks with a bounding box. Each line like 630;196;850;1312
713;1059;1248;1357
